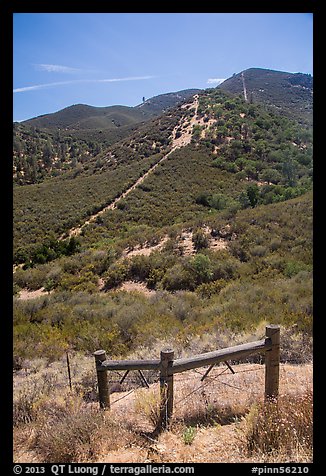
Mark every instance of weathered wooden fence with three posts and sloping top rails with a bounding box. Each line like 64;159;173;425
94;325;280;428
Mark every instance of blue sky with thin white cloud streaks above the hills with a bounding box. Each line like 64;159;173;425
13;13;313;121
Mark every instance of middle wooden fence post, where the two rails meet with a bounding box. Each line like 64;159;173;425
158;349;174;429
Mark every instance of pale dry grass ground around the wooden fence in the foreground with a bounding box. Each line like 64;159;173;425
14;348;312;463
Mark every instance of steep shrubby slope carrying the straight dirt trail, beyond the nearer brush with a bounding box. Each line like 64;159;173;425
14;89;312;260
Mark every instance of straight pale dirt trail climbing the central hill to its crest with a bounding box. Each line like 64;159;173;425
60;94;200;240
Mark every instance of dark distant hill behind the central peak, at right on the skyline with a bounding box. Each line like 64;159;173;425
217;68;313;125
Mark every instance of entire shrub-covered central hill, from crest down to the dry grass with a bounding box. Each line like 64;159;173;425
14;85;312;356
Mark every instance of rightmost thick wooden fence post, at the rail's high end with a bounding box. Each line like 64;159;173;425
265;324;280;401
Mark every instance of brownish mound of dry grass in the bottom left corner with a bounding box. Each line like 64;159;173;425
14;391;140;463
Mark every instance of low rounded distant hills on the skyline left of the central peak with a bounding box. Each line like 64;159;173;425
22;89;200;131
